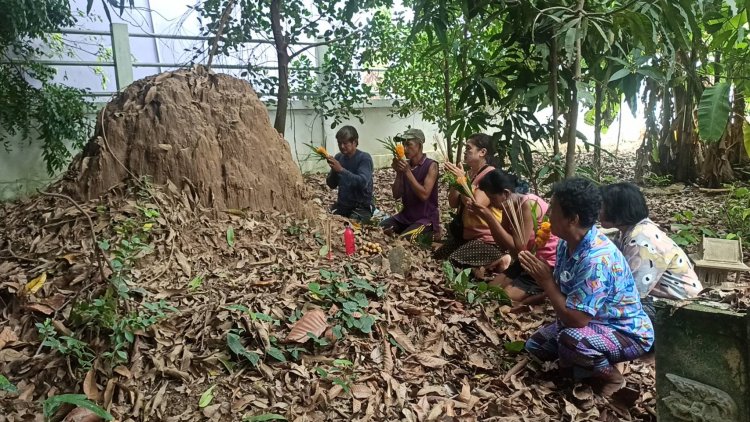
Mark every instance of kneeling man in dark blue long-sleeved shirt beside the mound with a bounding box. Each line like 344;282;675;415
326;126;373;221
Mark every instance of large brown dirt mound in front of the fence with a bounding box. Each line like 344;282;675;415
67;66;304;213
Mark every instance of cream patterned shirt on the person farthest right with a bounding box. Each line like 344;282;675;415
617;218;703;300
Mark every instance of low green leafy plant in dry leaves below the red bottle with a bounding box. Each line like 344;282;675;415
307;270;386;338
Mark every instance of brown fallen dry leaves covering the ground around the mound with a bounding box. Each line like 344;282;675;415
0;153;668;421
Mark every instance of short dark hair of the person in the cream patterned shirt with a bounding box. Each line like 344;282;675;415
600;182;648;226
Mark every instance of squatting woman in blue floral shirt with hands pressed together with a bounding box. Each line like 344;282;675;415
519;178;654;396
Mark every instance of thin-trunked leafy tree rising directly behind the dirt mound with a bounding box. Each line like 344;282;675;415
196;0;392;134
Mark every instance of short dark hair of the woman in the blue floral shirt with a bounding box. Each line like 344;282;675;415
552;177;602;227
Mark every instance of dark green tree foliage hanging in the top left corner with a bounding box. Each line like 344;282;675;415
0;0;91;175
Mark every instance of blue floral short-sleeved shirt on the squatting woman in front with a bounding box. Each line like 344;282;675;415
554;227;654;350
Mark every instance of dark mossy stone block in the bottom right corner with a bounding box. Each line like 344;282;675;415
654;300;750;422
